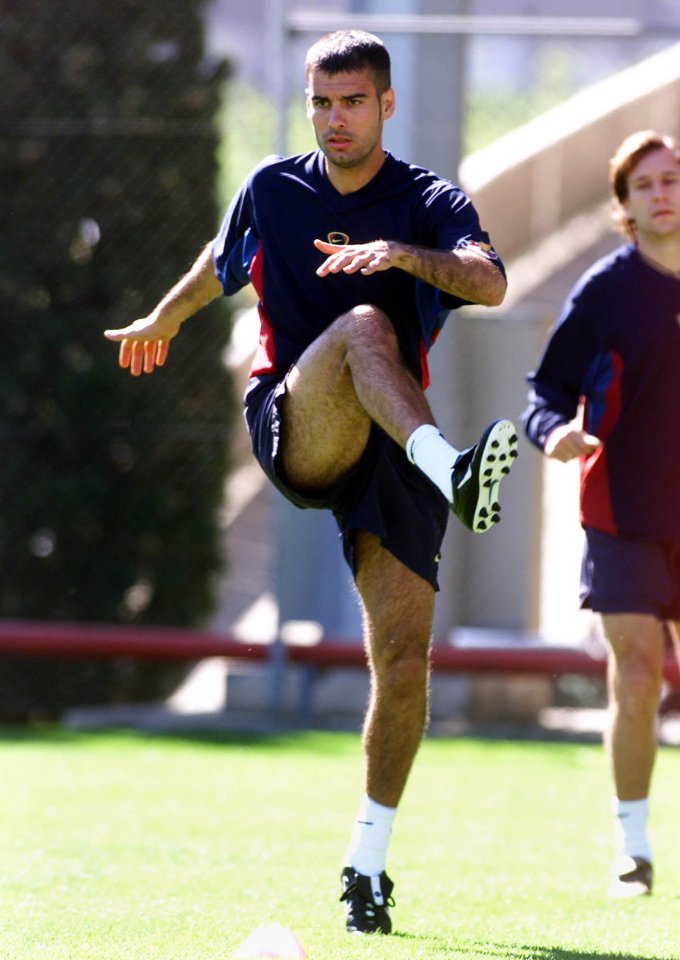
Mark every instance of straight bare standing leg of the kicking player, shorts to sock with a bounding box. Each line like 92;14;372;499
356;531;434;807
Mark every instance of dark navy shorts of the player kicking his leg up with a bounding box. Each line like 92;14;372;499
245;379;450;590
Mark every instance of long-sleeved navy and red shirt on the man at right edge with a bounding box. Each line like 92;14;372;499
522;244;680;540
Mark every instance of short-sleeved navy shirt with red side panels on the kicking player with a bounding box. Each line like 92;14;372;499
213;150;503;390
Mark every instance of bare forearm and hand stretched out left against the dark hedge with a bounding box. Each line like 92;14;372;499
104;243;222;377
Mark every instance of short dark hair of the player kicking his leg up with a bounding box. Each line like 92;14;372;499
305;30;392;94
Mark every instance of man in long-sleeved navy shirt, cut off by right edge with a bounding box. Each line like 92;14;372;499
523;130;680;897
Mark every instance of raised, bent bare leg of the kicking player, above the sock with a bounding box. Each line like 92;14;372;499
281;305;434;490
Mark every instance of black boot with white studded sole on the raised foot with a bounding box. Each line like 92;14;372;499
451;420;517;533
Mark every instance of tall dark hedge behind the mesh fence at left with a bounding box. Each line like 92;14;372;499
0;0;236;720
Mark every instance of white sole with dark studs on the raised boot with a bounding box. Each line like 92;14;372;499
458;420;517;533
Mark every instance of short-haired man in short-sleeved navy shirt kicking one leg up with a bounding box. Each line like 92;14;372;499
106;31;517;933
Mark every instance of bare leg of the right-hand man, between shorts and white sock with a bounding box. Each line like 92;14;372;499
602;613;665;800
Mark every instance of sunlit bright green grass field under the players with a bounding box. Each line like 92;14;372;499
0;729;680;960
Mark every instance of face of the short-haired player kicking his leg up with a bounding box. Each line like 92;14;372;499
307;68;394;181
